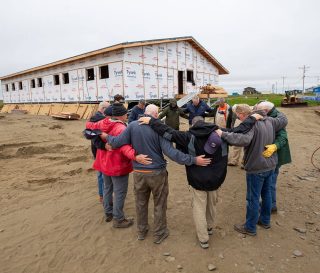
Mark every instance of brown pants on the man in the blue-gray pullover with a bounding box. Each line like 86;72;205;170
133;170;169;236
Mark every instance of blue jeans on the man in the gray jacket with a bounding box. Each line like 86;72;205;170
245;170;274;232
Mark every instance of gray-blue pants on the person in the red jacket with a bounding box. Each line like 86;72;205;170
103;174;129;221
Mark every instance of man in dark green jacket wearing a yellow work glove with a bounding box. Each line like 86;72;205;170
255;101;291;213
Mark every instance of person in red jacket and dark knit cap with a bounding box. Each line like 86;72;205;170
87;103;148;228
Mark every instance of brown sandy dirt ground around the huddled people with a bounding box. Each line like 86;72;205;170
0;108;320;273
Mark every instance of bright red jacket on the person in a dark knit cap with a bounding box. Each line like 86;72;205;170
86;118;135;176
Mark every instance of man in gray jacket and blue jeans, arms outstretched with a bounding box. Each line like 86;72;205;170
216;104;288;236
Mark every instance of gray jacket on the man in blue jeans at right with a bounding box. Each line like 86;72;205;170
221;113;288;173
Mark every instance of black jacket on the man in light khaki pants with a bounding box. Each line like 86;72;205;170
150;118;228;191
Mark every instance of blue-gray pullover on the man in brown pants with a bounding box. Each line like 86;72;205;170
107;121;196;170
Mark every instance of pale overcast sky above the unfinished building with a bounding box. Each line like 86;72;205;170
0;0;320;96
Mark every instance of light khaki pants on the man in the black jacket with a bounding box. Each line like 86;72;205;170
191;187;218;242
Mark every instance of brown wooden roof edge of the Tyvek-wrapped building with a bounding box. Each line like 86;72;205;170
0;36;229;80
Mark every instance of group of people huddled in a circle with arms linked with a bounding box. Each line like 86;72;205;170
86;92;291;249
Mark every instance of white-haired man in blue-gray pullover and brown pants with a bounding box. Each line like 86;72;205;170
104;104;210;244
